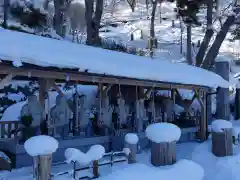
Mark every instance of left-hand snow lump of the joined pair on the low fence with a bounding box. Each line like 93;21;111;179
64;148;91;166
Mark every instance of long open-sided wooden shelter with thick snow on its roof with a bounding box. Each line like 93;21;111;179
0;29;229;167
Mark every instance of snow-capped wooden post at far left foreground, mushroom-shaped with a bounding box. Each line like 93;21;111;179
24;135;58;180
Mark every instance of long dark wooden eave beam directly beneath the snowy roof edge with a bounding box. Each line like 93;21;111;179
0;66;208;90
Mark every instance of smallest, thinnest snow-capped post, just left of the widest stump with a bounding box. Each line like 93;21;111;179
125;133;139;164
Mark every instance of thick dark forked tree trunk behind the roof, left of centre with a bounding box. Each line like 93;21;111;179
85;0;103;45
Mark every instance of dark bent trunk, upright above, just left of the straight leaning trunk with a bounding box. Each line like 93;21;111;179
196;0;214;66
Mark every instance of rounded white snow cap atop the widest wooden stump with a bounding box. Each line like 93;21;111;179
145;123;181;143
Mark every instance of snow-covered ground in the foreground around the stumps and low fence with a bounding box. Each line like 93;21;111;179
0;141;240;180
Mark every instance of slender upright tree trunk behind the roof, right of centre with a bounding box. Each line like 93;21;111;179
149;1;158;57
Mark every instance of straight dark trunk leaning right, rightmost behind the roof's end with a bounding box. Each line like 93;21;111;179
202;15;235;69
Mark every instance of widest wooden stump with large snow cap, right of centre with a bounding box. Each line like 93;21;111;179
146;123;181;166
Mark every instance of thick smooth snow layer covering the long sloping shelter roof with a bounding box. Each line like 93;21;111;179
0;28;229;88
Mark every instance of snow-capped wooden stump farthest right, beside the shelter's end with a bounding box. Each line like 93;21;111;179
212;119;233;157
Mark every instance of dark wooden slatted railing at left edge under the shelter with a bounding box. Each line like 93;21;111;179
0;121;20;139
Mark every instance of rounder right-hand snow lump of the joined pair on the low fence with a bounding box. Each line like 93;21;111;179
86;144;105;161
